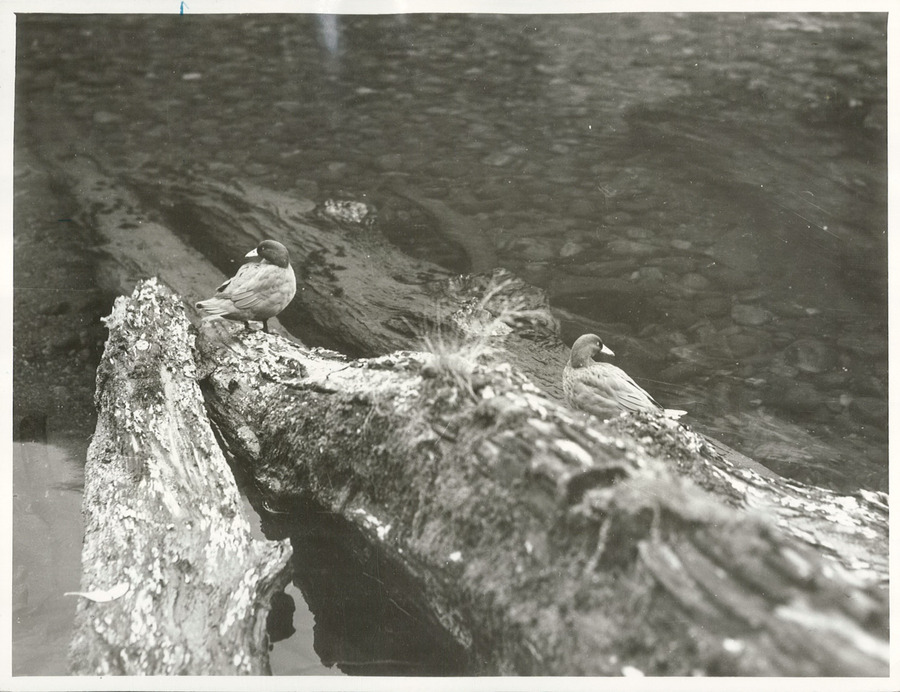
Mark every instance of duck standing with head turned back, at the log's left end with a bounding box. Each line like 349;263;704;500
196;239;297;334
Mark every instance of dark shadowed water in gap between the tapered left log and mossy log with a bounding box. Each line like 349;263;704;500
244;487;467;676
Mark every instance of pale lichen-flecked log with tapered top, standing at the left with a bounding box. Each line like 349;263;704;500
70;281;290;675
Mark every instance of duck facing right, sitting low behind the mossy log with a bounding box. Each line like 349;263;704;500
563;334;686;419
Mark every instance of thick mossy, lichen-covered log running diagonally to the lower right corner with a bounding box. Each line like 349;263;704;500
183;282;888;675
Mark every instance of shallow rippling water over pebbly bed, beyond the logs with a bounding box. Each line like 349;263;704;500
17;13;888;672
